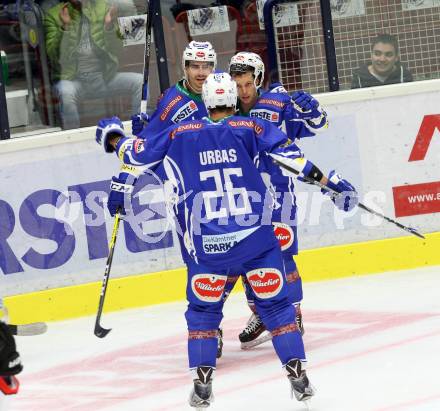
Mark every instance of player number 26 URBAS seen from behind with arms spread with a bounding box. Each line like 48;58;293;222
96;73;356;408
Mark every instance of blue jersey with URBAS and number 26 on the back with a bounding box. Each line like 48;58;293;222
116;116;311;268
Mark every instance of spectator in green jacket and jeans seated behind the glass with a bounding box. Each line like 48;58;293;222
44;0;143;129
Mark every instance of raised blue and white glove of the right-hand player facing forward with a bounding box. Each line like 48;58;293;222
291;90;328;130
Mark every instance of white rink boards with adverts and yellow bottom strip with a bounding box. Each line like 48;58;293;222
0;80;440;322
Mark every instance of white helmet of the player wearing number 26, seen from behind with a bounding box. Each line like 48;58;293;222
202;73;237;110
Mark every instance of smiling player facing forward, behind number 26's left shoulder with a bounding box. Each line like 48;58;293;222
132;41;217;136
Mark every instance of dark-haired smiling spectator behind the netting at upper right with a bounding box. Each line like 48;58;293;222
351;34;412;88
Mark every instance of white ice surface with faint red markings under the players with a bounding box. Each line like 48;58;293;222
5;267;440;411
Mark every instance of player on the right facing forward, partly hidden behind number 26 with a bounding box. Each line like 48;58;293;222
226;52;330;349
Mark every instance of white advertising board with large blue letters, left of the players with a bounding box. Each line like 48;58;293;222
0;138;182;296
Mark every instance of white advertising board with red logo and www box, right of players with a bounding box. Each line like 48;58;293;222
290;90;440;250
